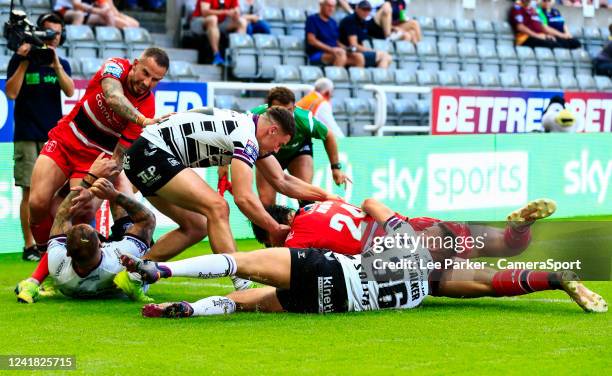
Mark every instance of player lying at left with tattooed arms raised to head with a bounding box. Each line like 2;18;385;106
15;155;155;303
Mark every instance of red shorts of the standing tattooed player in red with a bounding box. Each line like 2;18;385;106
40;124;110;179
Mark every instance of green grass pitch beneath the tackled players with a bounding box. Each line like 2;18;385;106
0;241;612;375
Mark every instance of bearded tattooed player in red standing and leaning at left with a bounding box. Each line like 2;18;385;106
29;48;169;253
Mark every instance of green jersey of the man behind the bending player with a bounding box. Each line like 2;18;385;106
250;104;327;163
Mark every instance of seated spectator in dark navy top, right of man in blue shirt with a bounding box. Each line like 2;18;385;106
340;0;392;68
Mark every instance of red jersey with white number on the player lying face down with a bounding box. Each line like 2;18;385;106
285;200;440;255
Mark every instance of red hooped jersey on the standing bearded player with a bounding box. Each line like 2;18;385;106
49;58;155;154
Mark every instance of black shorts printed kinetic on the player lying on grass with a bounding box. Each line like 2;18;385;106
276;248;348;313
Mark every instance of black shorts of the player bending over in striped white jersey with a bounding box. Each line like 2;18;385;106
123;137;187;197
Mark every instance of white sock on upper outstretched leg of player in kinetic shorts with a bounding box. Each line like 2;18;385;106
157;253;237;278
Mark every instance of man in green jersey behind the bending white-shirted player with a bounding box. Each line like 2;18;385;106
250;86;349;206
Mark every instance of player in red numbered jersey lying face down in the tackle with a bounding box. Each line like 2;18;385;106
251;199;556;258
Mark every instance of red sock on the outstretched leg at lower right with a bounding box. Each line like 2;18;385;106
491;269;561;296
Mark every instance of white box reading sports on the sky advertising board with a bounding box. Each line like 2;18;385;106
427;151;528;210
